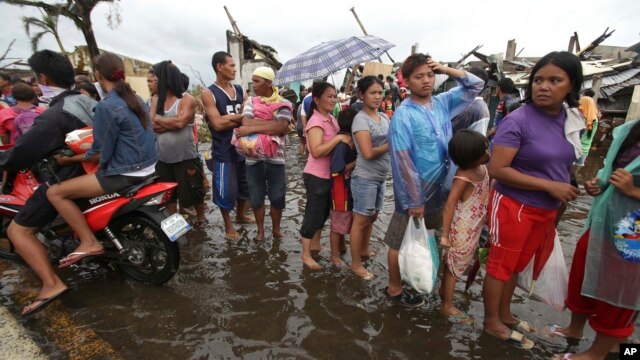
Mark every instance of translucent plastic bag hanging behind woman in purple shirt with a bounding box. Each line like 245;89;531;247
518;232;569;311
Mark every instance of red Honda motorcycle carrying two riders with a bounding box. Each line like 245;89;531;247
0;153;191;284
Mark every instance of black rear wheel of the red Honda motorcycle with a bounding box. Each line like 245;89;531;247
109;213;180;285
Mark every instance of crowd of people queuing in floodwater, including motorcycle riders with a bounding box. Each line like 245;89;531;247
0;50;640;359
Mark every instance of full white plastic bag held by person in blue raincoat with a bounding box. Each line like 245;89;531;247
398;218;440;294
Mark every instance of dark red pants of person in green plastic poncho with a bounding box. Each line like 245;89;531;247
565;231;638;338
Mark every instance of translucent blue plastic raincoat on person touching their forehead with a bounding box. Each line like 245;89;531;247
388;73;484;213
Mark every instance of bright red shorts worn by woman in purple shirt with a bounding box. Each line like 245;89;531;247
487;191;557;281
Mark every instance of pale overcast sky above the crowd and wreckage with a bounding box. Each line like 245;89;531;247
0;0;640;84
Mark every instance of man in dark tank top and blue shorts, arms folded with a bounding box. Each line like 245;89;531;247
201;51;254;240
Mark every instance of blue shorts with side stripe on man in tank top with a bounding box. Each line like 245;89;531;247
211;160;249;211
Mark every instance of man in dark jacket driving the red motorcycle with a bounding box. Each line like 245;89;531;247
0;50;97;315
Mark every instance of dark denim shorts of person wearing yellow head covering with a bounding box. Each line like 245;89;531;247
247;161;287;209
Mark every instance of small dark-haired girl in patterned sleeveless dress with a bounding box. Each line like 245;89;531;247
440;129;489;323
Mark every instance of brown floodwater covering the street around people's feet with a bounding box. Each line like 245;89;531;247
0;136;638;359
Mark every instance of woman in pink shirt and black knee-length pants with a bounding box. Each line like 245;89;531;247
300;82;351;270
